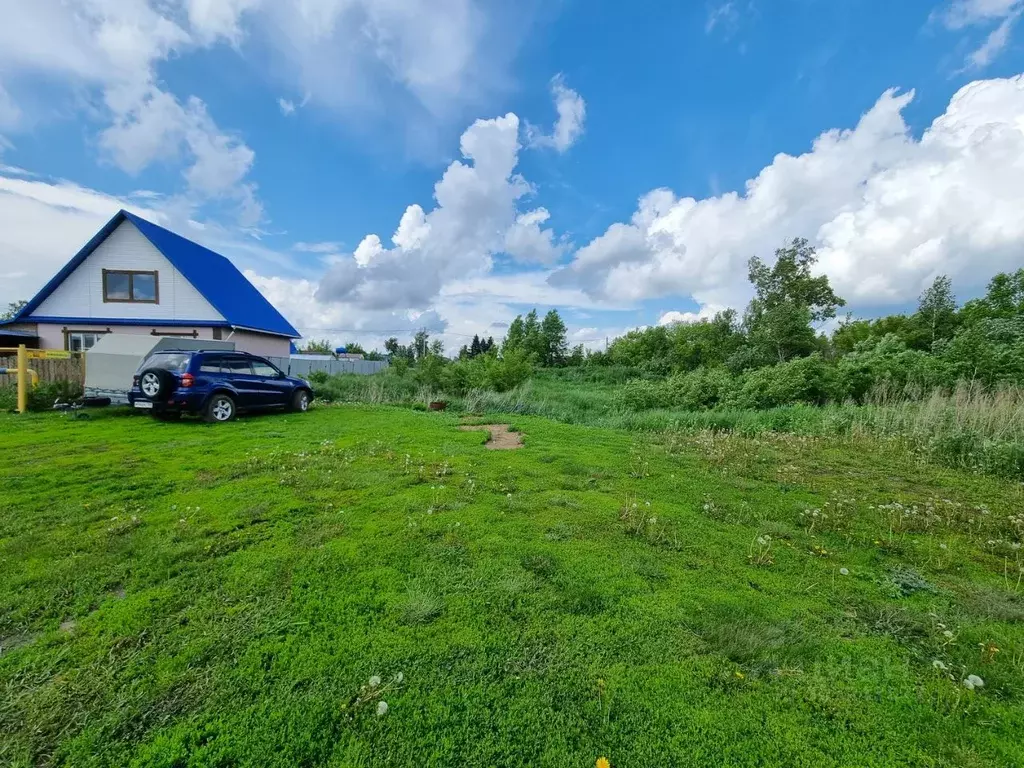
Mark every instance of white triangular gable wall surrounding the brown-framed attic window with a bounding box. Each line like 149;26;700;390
31;221;224;322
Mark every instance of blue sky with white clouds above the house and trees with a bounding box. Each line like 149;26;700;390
0;0;1024;348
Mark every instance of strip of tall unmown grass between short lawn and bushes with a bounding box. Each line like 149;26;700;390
316;372;1024;480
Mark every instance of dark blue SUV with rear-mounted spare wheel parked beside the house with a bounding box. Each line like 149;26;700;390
128;349;313;422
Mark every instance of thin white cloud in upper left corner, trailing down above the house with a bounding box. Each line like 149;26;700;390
0;0;262;224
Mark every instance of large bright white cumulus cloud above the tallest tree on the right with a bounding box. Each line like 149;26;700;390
551;76;1024;315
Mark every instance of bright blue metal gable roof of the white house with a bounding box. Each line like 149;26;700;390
10;211;300;339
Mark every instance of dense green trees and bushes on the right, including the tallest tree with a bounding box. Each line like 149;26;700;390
588;240;1024;409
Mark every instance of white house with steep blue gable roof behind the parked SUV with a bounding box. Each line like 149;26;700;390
0;211;299;357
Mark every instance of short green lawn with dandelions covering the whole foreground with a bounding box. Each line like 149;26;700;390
0;407;1024;768
